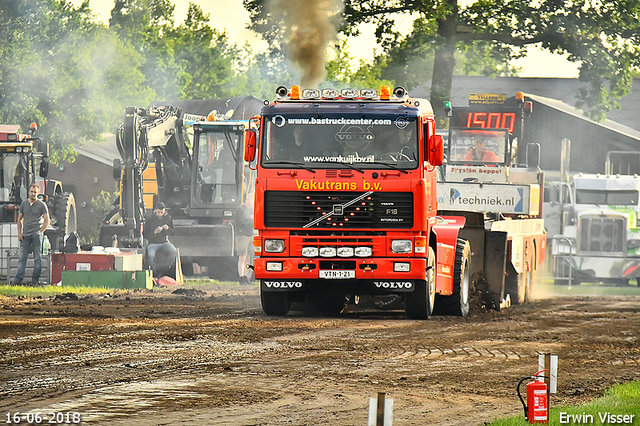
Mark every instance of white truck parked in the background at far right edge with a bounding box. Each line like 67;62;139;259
544;152;640;285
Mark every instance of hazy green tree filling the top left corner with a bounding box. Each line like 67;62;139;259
0;0;148;162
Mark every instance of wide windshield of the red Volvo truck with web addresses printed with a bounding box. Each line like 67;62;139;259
261;116;418;170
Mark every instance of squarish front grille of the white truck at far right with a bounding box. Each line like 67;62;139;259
580;216;626;253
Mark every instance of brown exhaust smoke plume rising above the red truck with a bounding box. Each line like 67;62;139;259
267;0;344;88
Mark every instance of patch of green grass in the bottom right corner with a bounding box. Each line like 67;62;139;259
487;381;640;426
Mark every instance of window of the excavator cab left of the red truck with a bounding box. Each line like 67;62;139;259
195;131;240;204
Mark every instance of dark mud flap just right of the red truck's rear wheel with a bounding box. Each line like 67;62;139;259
484;231;507;311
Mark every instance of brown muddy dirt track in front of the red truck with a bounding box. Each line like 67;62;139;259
0;284;640;426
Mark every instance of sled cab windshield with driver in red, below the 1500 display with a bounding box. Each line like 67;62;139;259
447;129;508;165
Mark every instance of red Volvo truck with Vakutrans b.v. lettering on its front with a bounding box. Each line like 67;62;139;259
245;86;470;319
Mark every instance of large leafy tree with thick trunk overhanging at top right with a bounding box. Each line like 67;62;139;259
345;0;640;123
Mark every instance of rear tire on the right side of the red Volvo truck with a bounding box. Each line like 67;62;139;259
434;238;471;317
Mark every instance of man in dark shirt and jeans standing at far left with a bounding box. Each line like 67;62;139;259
13;183;50;285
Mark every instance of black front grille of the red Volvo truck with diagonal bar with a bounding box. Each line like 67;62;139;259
265;191;413;229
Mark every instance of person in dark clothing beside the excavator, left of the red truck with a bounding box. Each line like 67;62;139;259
142;202;178;278
